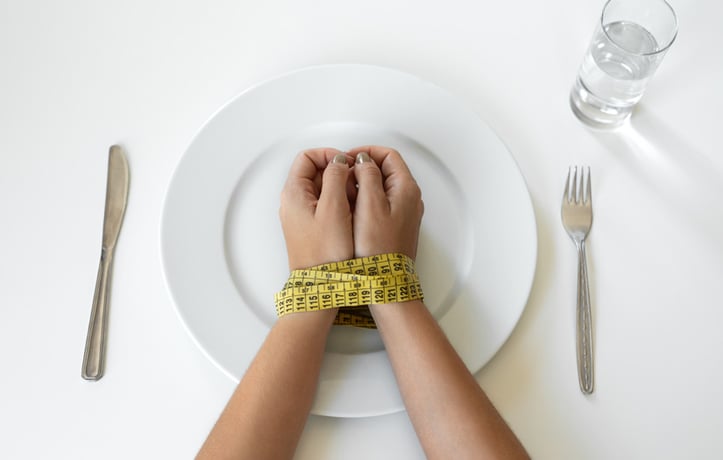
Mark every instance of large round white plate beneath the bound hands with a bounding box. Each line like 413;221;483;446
161;65;537;417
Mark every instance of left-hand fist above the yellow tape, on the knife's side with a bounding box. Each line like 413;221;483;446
279;148;354;270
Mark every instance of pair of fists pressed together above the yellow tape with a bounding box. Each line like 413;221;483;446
279;146;424;270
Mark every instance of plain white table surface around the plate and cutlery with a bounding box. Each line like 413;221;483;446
0;0;723;460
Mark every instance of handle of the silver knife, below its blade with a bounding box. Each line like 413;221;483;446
81;248;113;380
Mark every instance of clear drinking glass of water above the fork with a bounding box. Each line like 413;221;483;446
570;0;678;128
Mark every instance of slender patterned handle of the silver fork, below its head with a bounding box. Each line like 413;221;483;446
577;240;594;394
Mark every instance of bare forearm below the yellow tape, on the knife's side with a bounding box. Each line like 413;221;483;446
198;310;336;459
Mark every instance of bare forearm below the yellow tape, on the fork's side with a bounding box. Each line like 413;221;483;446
371;301;528;459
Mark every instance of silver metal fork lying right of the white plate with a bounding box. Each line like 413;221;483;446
562;166;594;394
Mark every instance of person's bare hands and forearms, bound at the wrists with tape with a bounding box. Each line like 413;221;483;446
198;146;529;459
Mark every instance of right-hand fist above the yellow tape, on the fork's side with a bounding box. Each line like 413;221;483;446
349;146;424;259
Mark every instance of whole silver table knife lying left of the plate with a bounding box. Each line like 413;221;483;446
81;145;129;380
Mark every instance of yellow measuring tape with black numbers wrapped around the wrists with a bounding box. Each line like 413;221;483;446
274;253;424;328
